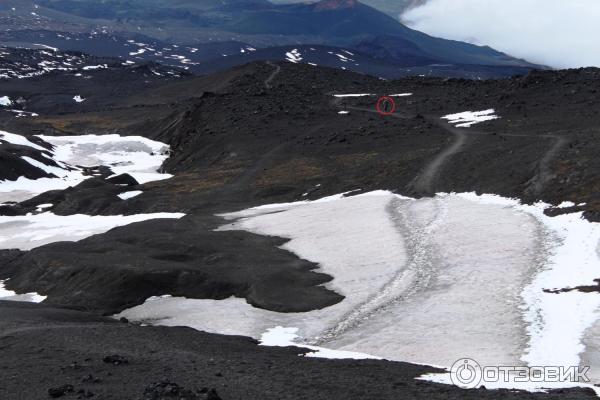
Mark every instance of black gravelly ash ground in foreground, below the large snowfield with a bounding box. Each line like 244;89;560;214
0;301;596;400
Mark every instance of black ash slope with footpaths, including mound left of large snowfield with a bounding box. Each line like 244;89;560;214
0;63;600;313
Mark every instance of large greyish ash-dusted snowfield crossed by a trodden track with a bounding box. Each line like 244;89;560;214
118;191;600;390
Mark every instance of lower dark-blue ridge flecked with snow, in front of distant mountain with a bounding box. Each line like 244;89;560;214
0;31;528;79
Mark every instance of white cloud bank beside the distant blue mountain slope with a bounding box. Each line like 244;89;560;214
401;0;600;68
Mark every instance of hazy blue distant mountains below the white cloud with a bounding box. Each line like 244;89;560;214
0;0;538;78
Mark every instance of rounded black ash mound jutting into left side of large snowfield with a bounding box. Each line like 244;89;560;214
0;217;343;315
